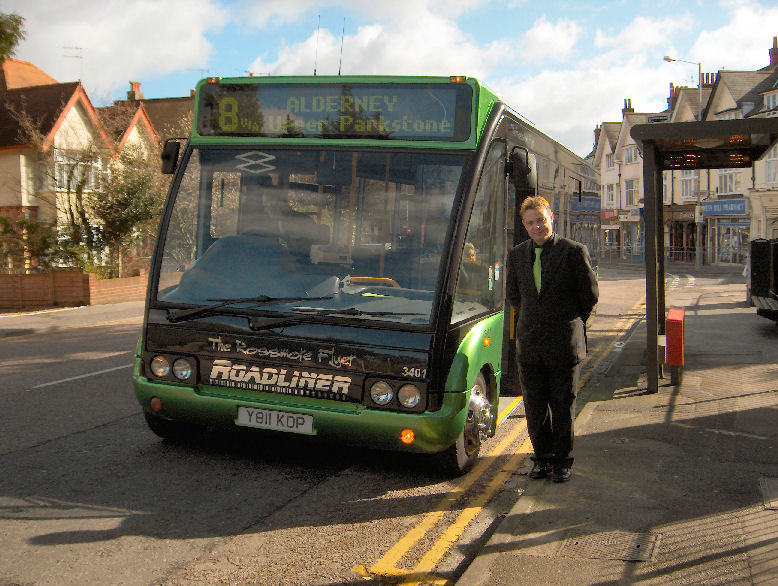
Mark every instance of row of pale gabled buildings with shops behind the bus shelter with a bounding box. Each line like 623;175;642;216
595;37;778;264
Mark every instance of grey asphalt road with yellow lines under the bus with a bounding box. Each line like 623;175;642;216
0;269;728;584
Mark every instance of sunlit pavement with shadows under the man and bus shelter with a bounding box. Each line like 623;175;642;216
457;267;778;586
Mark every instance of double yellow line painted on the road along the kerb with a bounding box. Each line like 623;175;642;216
352;297;644;586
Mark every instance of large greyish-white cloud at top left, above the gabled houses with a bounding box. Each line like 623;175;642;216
3;0;228;101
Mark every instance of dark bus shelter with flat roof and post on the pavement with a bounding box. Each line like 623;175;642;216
630;118;778;393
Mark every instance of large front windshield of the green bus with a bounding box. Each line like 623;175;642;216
155;146;464;325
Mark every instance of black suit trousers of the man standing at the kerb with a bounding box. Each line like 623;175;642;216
519;356;581;467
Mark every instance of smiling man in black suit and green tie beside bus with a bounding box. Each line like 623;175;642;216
506;196;599;482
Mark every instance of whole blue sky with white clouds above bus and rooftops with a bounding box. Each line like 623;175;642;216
6;0;778;156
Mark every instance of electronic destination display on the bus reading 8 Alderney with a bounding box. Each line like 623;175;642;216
197;83;473;142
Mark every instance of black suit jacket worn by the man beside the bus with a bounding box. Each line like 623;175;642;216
506;234;599;366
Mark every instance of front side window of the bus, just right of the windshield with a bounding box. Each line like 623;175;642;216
452;142;506;321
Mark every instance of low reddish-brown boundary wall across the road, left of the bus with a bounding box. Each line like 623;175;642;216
0;271;148;311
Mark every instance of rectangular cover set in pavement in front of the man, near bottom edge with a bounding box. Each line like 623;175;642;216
557;531;661;562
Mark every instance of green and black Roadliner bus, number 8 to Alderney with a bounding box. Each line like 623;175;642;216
133;76;596;473
